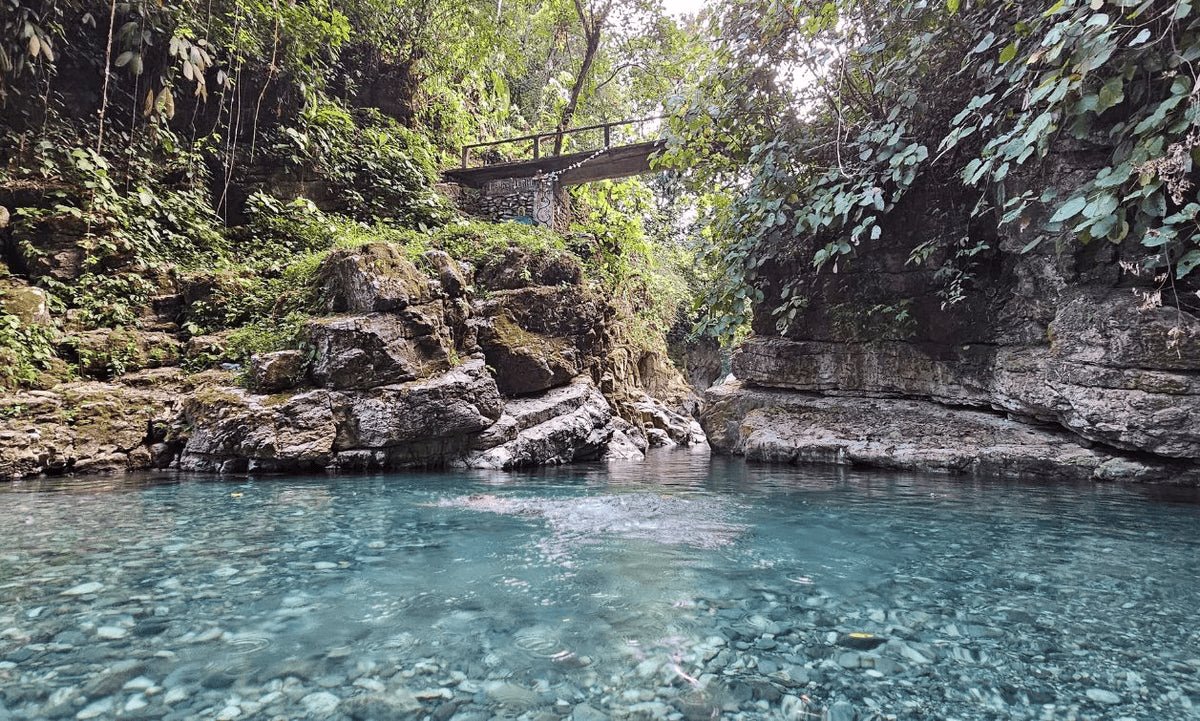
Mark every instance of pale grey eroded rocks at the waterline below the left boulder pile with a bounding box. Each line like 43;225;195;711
180;358;633;473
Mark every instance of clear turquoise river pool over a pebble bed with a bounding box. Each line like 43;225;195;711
0;452;1200;721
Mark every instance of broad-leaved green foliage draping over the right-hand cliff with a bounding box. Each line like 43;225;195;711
666;0;1200;338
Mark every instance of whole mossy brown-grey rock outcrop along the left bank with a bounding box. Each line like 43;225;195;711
0;238;703;477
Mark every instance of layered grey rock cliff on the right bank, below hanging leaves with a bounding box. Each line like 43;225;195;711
703;146;1200;483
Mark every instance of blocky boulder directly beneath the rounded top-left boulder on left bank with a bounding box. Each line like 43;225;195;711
307;304;452;390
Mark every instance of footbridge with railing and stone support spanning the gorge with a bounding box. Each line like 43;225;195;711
442;116;666;227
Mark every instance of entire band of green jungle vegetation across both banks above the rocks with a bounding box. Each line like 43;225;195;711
0;0;1200;384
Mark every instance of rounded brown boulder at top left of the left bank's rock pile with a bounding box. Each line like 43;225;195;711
317;242;436;313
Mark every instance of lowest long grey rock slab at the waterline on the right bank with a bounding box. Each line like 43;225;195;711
703;383;1200;483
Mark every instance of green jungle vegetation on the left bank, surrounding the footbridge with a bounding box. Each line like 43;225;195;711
0;0;704;384
